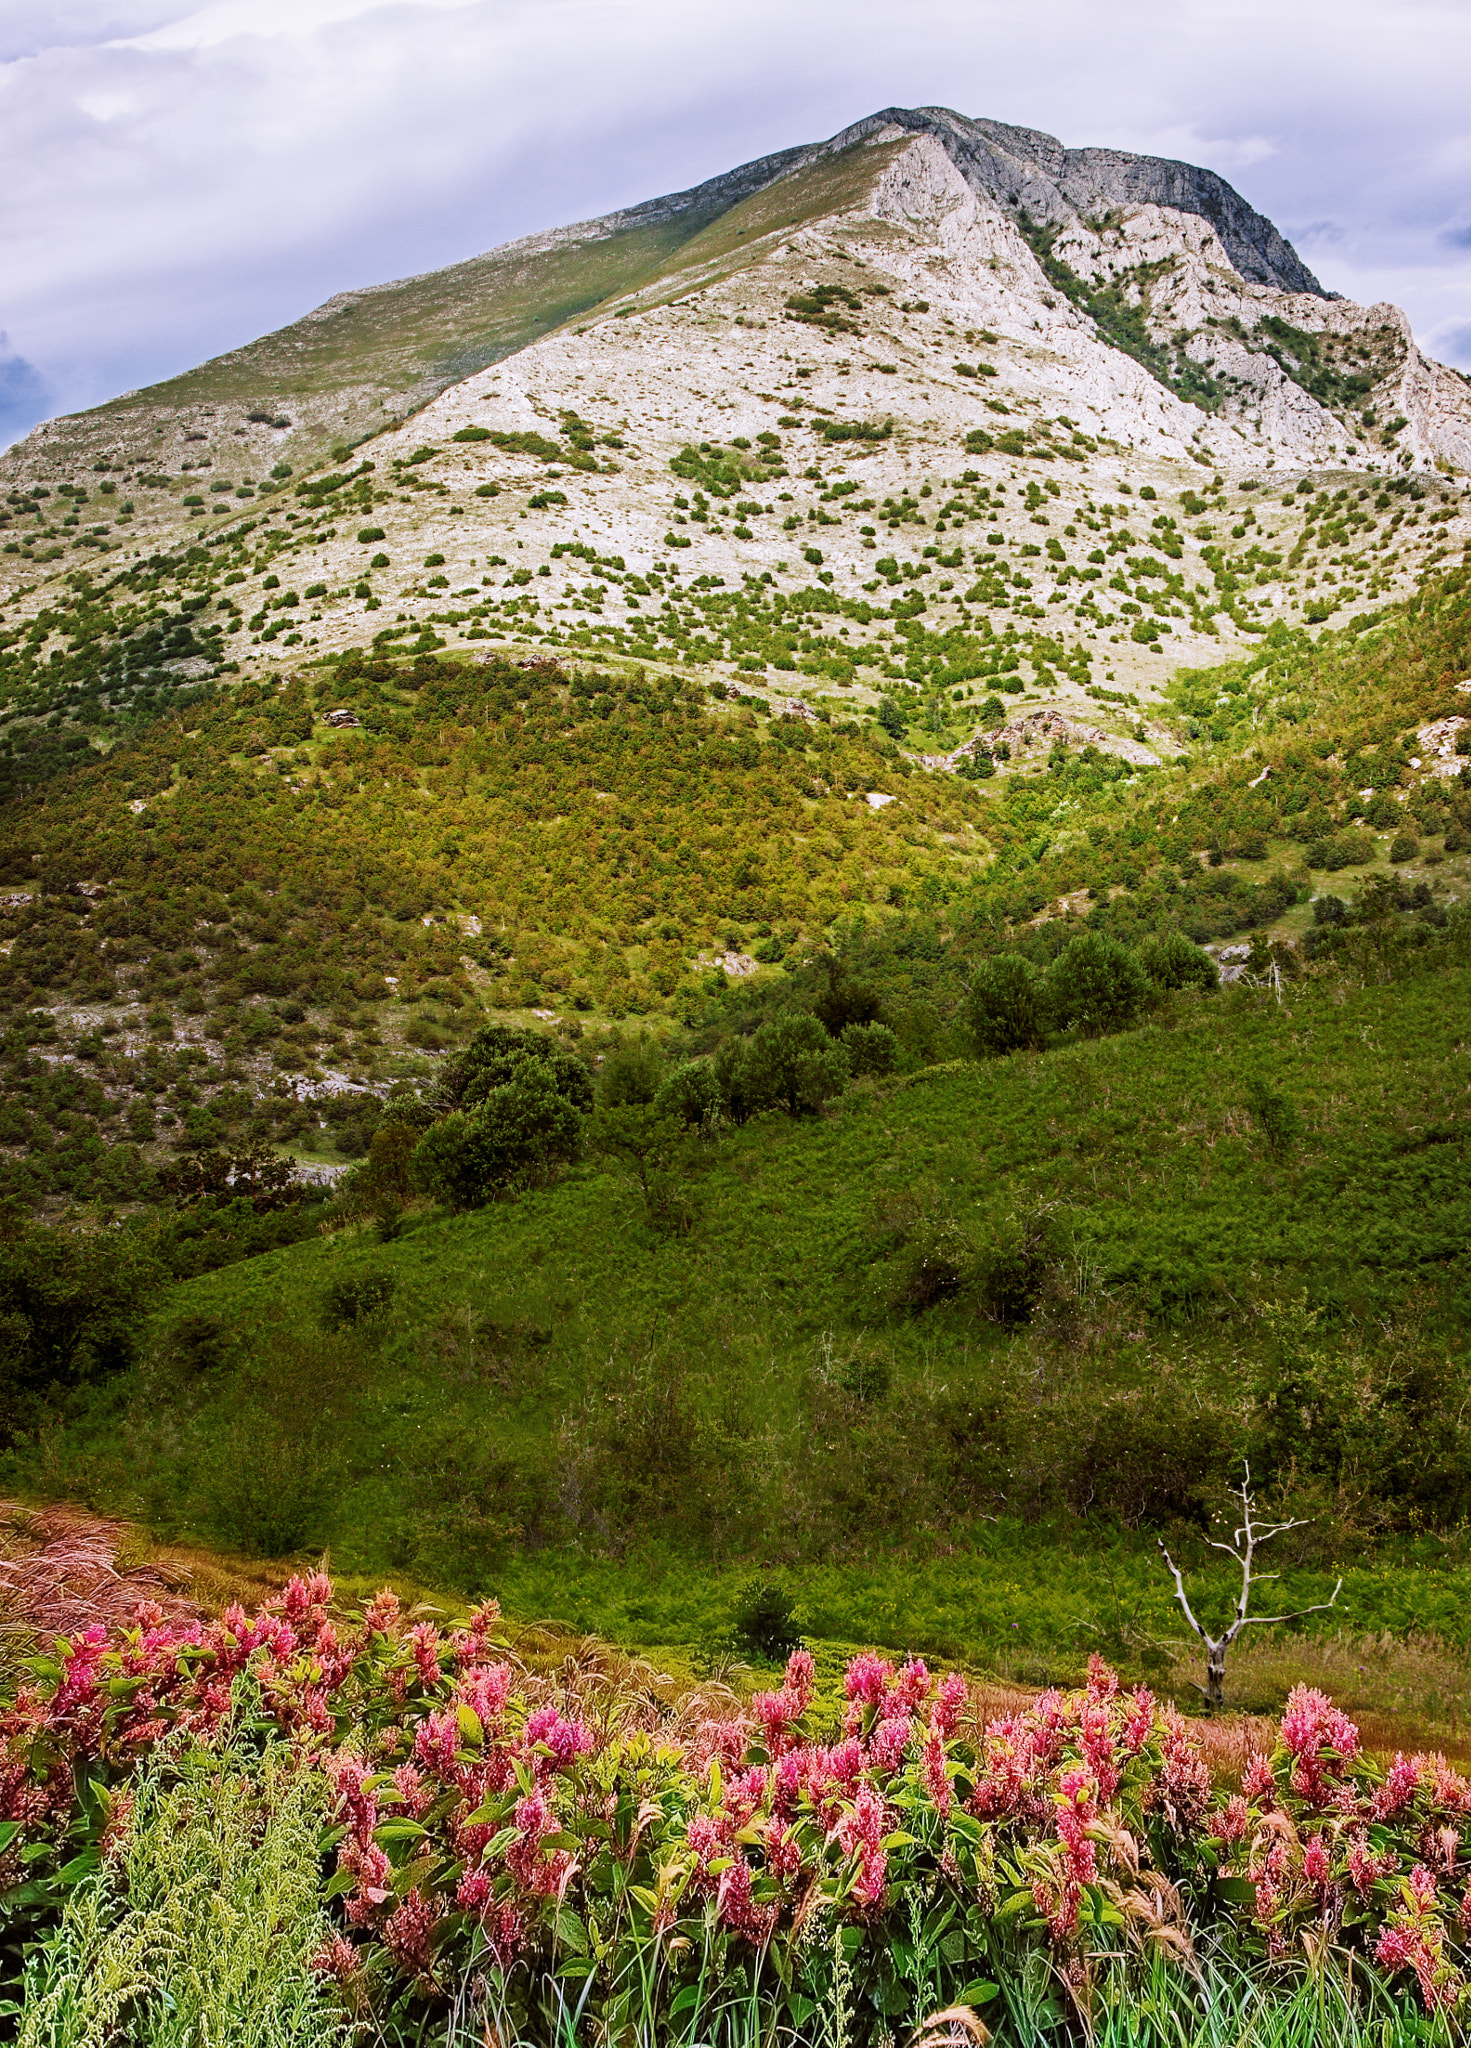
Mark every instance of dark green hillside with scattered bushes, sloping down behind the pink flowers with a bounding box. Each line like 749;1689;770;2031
6;918;1471;1663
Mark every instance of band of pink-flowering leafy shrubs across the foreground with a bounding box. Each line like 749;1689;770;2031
0;1575;1471;2038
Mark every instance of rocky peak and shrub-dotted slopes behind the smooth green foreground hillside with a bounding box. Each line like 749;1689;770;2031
0;109;1471;1200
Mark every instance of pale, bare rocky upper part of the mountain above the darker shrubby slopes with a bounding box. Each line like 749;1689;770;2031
0;109;1471;733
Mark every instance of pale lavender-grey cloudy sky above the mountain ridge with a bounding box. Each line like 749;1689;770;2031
0;0;1471;444
